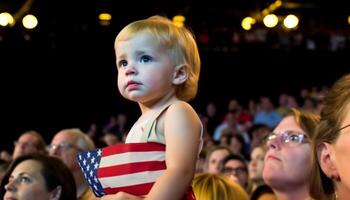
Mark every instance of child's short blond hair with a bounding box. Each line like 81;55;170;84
115;15;200;101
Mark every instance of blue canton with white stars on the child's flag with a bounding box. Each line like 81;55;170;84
78;149;105;197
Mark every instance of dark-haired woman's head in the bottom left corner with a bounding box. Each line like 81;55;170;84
0;154;76;200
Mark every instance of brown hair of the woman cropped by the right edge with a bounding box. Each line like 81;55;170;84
310;74;350;200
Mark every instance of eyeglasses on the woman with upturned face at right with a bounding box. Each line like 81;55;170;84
265;131;309;146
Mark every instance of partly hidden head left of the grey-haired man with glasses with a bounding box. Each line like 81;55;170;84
12;131;47;159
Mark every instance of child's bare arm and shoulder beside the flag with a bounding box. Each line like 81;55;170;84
146;101;201;200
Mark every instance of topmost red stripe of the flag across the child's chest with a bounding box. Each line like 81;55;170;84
102;142;165;157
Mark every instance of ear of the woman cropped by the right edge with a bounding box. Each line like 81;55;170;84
317;143;339;180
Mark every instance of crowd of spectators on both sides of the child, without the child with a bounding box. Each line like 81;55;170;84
0;75;350;199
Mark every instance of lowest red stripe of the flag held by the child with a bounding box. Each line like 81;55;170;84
104;182;154;196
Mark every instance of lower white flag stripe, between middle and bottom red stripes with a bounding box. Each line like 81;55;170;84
99;170;164;188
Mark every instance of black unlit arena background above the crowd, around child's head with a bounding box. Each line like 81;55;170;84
0;0;350;148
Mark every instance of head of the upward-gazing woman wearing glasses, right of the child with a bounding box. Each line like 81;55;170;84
263;109;319;200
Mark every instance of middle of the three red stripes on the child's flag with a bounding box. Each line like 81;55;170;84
97;161;166;178
